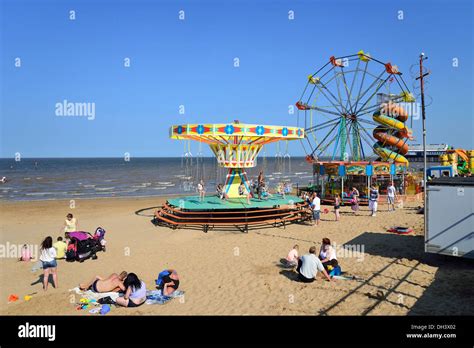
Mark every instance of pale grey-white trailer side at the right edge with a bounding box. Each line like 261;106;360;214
425;177;474;258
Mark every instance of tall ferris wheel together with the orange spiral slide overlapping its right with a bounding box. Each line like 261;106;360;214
296;51;415;164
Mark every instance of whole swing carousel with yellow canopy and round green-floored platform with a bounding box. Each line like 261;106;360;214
155;121;310;232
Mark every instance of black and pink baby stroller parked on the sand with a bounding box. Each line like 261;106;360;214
66;227;105;262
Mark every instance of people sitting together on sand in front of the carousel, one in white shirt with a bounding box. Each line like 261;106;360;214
286;238;339;283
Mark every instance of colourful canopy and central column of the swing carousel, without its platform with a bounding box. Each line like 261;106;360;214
170;121;305;198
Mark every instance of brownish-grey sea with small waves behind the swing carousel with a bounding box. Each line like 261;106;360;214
0;157;312;201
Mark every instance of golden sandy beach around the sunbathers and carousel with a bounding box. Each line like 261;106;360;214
0;197;474;315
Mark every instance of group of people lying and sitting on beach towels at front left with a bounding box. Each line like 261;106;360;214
79;269;179;307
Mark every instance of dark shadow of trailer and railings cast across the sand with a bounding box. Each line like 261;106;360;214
320;232;474;315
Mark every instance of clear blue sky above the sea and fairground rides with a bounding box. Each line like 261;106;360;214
0;0;474;157
